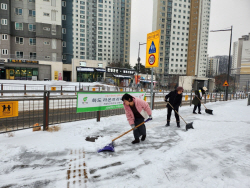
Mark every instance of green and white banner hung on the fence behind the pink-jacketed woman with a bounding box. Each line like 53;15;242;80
77;92;146;113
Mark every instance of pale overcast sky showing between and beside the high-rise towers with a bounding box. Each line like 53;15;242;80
130;0;250;66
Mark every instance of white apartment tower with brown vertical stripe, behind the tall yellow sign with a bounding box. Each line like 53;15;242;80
153;0;210;80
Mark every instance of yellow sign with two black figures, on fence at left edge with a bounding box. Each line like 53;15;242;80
0;101;18;118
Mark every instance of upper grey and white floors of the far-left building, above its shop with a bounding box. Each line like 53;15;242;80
0;0;62;61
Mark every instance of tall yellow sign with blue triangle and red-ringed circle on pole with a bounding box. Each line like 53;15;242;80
145;29;161;68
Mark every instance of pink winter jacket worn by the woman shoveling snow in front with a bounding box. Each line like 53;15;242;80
123;97;152;125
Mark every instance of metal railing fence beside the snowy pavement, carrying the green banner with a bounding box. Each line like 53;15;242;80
0;90;247;134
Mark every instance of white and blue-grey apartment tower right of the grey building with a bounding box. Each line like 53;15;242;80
62;0;131;64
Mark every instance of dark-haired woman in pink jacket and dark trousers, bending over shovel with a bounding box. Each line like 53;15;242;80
122;94;152;144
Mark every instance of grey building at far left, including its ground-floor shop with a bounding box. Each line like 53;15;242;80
0;0;62;79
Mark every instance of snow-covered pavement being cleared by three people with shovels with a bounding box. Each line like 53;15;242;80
0;100;250;188
